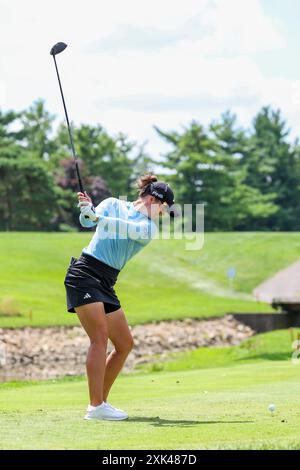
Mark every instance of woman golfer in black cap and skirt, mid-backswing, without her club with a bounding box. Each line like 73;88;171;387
65;175;176;420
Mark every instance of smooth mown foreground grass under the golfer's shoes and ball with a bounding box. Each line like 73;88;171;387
0;361;300;450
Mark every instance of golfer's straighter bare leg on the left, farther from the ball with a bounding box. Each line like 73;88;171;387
75;302;108;406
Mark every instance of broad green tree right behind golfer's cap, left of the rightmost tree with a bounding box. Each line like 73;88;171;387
158;113;275;230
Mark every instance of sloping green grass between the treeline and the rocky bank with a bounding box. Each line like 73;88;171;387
0;232;300;327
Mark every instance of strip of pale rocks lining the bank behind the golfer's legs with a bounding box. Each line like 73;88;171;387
0;316;255;381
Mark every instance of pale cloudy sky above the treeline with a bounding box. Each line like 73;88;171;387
0;0;300;157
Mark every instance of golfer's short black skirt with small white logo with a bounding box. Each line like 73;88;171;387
64;253;121;313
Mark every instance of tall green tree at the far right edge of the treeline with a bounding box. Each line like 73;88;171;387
241;107;300;230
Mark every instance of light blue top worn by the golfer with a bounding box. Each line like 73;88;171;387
79;197;158;270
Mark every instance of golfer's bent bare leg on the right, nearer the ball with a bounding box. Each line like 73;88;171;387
103;309;134;401
